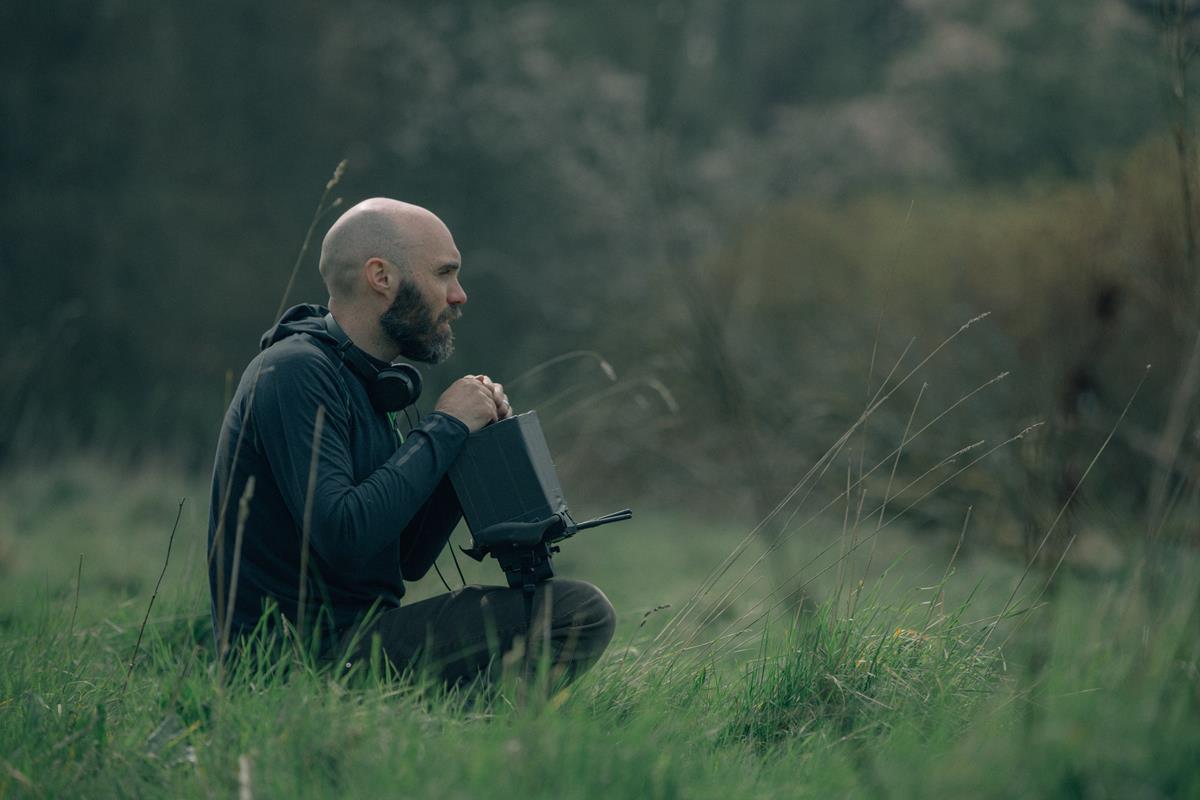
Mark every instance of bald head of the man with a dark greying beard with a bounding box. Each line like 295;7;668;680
320;198;467;363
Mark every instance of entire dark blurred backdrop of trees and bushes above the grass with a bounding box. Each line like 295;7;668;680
0;0;1200;551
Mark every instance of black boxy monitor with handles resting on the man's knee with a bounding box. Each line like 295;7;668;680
450;411;634;600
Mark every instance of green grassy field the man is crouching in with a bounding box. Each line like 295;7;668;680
0;457;1200;798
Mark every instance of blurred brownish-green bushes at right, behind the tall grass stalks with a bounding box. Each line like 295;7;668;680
625;139;1200;541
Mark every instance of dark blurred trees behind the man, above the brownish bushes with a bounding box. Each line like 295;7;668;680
0;0;1180;465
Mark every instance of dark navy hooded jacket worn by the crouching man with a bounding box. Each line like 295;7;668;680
209;305;468;642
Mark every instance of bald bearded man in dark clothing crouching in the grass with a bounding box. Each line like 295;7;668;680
209;198;614;684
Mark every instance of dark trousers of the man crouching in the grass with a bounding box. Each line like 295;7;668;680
343;578;617;685
